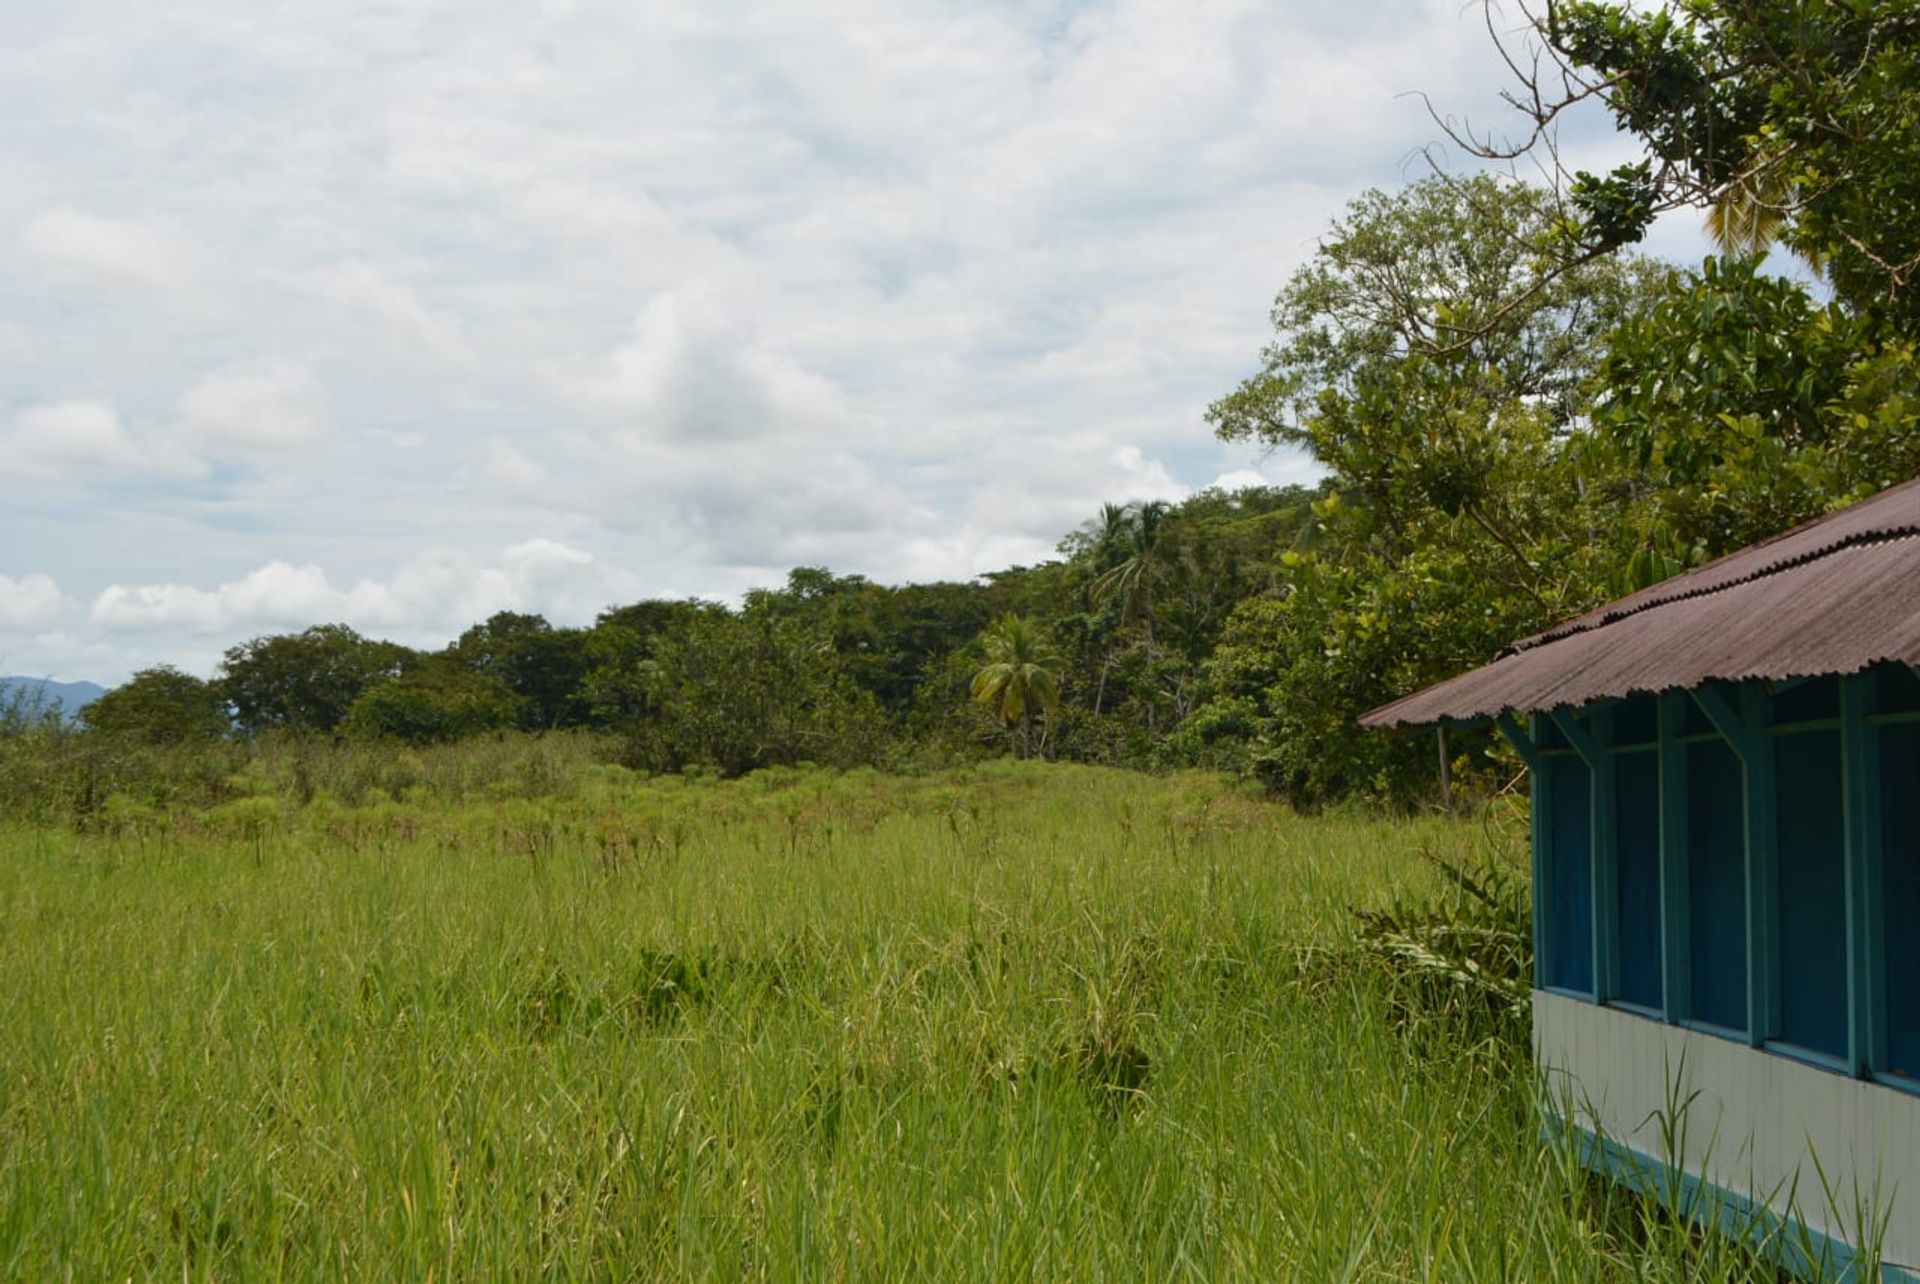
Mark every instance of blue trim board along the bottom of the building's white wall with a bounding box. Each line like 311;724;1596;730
1540;1111;1920;1284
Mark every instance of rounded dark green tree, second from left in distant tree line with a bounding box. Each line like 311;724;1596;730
219;624;415;735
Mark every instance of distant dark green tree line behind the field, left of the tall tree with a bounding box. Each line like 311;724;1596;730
83;475;1313;773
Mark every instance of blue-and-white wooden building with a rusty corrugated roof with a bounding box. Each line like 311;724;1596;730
1365;482;1920;1282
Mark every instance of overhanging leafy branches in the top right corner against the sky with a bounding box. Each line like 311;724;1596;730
1497;0;1920;320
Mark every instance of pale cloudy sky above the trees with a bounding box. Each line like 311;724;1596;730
0;0;1697;683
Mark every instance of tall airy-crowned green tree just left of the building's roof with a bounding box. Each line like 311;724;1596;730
1181;177;1672;804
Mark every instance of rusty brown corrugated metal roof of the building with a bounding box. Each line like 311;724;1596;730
1361;478;1920;727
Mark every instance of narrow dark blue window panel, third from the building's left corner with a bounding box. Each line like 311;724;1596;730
1682;739;1747;1031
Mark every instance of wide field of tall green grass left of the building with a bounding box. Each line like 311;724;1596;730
0;749;1770;1282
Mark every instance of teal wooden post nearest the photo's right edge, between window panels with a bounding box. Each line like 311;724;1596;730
1839;670;1887;1075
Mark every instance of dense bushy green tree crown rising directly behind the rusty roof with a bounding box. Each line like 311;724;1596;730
1584;259;1920;579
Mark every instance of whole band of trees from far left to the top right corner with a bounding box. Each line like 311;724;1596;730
56;0;1920;804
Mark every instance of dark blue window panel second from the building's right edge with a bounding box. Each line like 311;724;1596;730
1772;725;1847;1058
